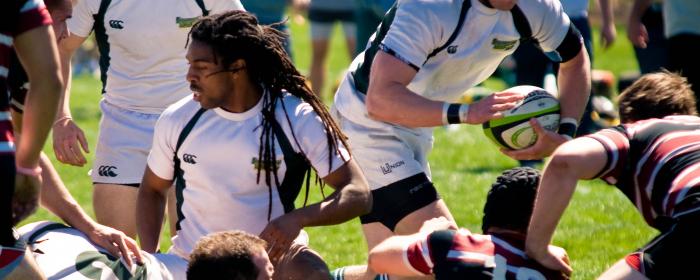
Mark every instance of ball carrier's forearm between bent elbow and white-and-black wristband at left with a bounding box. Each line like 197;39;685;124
366;83;444;127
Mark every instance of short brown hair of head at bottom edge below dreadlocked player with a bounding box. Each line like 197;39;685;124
187;230;266;280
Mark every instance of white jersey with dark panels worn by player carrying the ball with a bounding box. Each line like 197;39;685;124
334;0;570;128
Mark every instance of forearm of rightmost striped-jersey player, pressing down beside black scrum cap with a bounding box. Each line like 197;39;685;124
526;155;578;258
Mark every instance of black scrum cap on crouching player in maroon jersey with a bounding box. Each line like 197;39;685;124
481;167;540;233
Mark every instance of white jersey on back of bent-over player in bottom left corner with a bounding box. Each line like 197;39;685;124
18;221;186;280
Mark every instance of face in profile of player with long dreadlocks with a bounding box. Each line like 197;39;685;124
186;40;233;109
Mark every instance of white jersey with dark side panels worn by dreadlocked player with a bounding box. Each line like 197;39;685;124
148;94;350;258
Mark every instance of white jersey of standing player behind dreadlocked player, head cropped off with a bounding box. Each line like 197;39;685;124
68;0;243;114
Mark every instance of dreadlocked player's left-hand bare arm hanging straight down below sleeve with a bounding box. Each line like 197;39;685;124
136;167;173;253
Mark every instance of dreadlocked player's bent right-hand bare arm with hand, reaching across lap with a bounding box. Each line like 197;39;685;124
260;159;372;259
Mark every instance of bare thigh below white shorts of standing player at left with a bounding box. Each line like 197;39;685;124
92;184;138;238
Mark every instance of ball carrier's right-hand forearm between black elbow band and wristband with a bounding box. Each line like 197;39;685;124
558;47;591;123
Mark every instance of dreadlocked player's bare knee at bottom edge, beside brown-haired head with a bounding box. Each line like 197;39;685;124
272;243;330;280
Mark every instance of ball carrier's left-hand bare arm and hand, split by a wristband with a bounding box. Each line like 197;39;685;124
366;51;522;127
